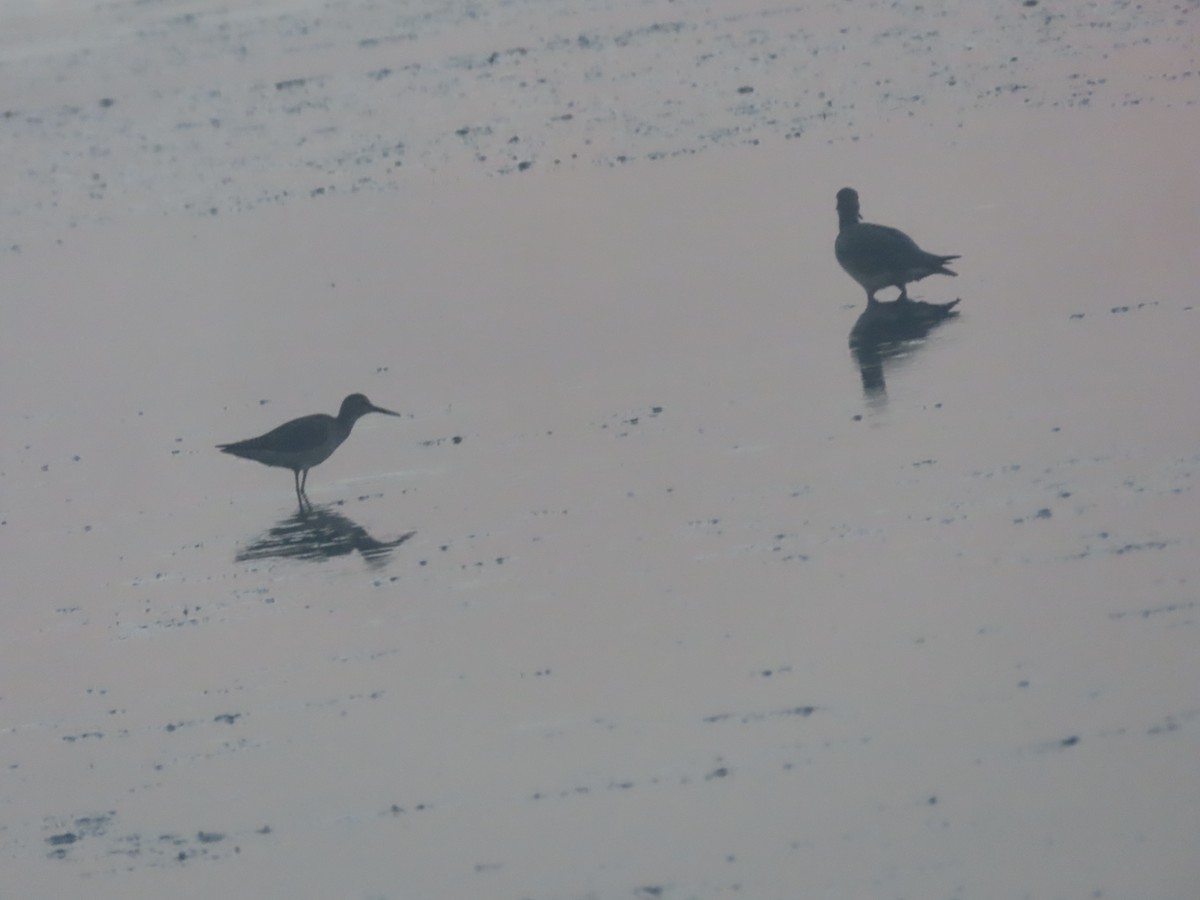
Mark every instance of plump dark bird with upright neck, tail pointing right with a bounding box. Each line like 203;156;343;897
833;187;959;306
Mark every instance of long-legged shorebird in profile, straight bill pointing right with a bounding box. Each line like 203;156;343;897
217;394;400;510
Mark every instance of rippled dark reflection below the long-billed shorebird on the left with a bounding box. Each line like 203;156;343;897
236;506;416;566
